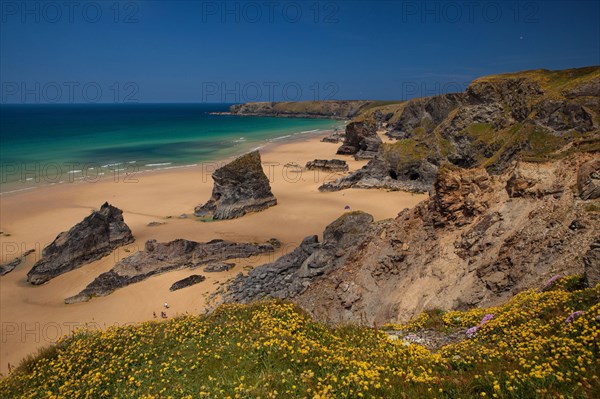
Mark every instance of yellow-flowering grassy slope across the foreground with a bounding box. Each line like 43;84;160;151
0;278;600;399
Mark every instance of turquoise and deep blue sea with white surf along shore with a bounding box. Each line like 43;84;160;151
0;104;342;193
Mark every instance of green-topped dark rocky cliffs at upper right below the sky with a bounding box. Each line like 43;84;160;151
323;67;600;191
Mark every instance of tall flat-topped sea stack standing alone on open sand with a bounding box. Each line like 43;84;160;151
194;151;277;219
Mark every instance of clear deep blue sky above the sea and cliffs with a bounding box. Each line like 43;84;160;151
0;0;600;103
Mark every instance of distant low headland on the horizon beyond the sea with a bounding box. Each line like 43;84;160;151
229;100;376;119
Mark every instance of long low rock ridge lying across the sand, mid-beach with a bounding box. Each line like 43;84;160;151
65;239;275;303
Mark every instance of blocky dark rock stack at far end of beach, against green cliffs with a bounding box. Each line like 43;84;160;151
337;122;382;159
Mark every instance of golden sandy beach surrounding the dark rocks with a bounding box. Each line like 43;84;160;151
0;134;426;375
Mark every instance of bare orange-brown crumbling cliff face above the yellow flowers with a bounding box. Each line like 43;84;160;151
294;154;600;324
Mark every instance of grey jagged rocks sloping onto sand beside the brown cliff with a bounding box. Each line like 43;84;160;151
224;212;373;302
